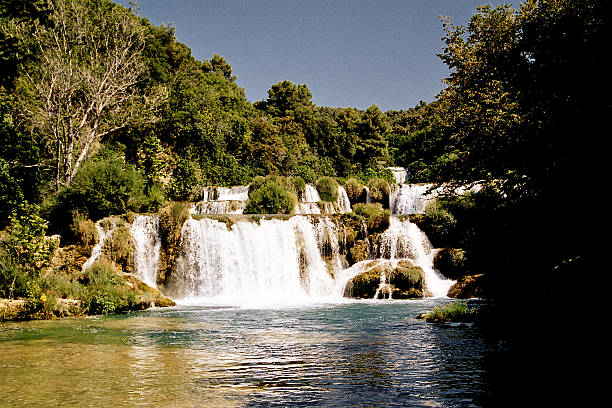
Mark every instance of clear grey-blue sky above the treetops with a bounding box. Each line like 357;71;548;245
126;0;519;110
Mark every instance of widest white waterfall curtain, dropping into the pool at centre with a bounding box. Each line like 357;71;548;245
168;216;333;303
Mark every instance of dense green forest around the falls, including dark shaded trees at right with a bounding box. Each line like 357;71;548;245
0;0;612;342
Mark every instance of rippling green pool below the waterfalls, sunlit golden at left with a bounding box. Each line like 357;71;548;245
0;300;498;407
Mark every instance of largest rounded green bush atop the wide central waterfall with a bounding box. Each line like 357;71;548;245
244;179;297;214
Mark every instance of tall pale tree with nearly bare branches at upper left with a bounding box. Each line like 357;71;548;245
8;0;164;189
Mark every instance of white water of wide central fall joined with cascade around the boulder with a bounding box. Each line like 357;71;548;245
167;212;454;304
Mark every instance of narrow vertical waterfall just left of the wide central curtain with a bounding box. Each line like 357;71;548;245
130;215;161;288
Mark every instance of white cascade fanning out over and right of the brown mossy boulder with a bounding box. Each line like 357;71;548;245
375;217;455;297
